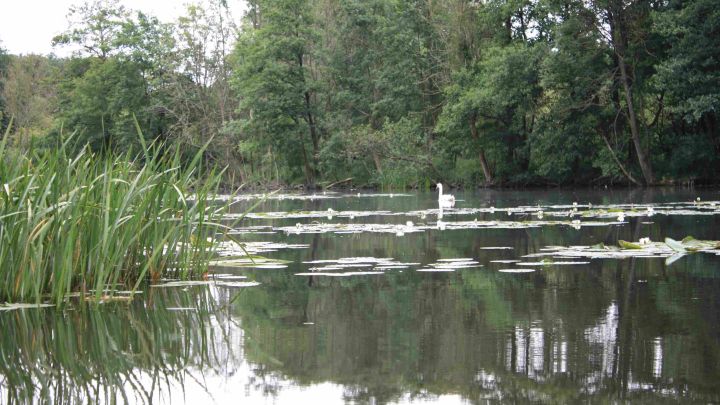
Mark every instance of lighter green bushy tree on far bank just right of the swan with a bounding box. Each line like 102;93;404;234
438;1;547;184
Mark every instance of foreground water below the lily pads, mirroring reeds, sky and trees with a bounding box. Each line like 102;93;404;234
0;256;720;403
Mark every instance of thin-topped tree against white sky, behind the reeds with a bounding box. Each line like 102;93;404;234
54;0;172;150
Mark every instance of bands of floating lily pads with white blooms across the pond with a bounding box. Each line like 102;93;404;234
186;199;720;286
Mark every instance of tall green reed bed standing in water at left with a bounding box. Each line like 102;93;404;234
0;124;227;304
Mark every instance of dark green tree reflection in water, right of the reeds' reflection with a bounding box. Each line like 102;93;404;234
233;256;720;403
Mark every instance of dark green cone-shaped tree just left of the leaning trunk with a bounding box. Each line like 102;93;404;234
531;0;640;184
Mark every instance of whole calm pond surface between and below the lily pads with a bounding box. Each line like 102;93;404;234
0;190;720;404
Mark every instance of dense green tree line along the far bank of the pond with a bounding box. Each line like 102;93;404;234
0;0;720;187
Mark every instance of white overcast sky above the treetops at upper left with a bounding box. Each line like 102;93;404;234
0;0;244;56
